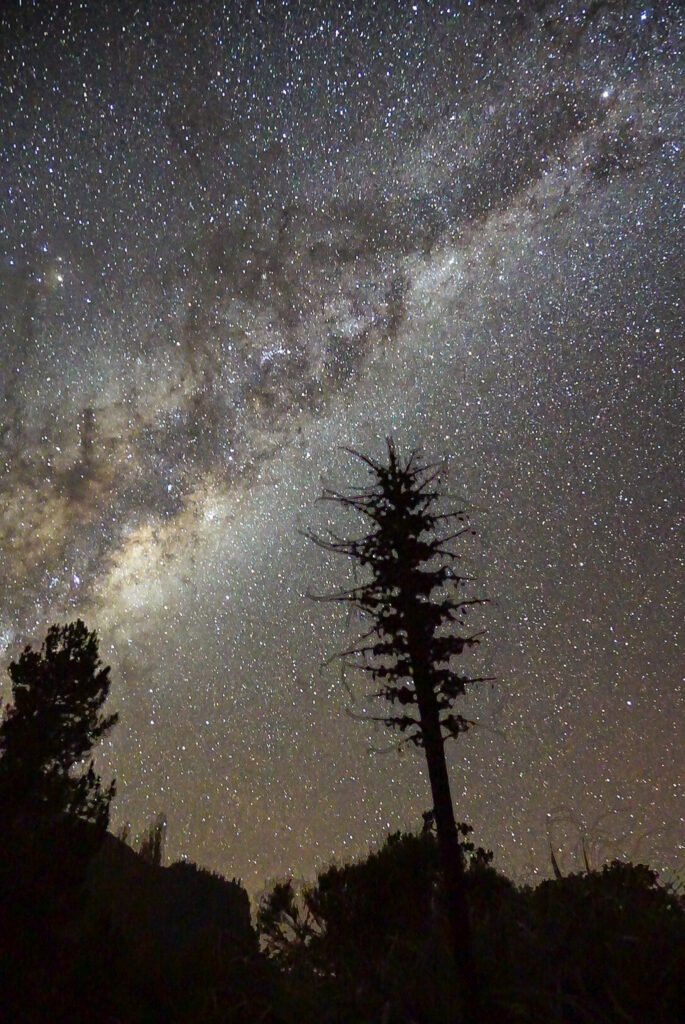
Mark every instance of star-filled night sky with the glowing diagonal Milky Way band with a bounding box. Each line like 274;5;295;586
0;0;685;892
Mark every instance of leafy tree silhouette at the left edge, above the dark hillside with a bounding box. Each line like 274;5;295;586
0;620;118;828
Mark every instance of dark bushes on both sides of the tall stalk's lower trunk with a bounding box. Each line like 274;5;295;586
258;826;685;1024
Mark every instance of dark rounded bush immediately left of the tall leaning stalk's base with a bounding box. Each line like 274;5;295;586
257;825;499;1022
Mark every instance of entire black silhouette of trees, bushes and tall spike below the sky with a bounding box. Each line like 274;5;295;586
0;456;685;1024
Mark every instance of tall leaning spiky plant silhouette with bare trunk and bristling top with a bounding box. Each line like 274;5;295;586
307;439;483;1015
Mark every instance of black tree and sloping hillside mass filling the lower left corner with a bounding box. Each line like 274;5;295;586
0;621;275;1024
